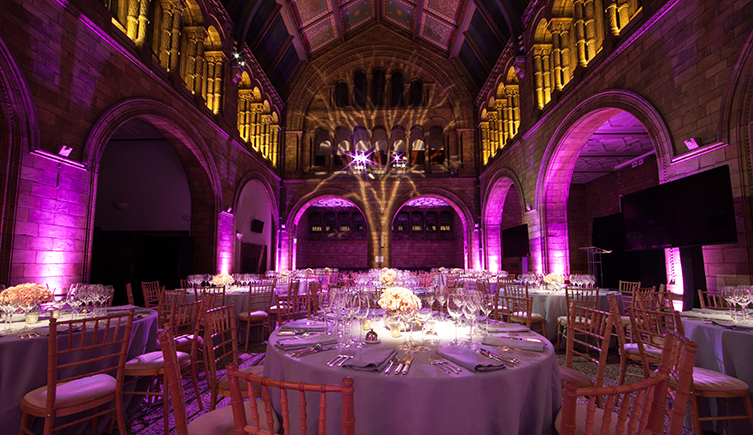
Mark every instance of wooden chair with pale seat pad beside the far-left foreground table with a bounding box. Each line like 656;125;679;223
33;310;134;434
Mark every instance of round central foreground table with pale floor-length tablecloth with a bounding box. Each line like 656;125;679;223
264;320;562;435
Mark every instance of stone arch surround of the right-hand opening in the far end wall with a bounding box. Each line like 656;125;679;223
382;187;470;269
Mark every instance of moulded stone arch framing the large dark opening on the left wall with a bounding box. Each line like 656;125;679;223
83;99;223;272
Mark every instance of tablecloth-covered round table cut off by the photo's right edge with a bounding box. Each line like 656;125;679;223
682;310;753;435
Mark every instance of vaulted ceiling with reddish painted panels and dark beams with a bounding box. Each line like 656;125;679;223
223;0;528;99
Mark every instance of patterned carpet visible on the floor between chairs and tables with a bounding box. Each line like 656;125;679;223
122;342;692;435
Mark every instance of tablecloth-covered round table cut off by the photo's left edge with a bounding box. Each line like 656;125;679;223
0;306;157;435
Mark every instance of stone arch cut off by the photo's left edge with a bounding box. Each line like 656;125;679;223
0;38;41;284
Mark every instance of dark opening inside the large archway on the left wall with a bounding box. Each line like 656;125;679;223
91;119;194;303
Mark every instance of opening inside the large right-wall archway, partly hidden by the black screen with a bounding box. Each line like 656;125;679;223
550;109;667;288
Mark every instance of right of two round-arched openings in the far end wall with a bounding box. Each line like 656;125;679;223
390;195;466;270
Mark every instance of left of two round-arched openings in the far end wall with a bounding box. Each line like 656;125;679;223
291;196;368;270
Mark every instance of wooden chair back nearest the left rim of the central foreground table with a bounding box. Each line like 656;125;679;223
203;304;238;410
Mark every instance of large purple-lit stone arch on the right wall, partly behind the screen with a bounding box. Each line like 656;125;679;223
532;90;672;273
